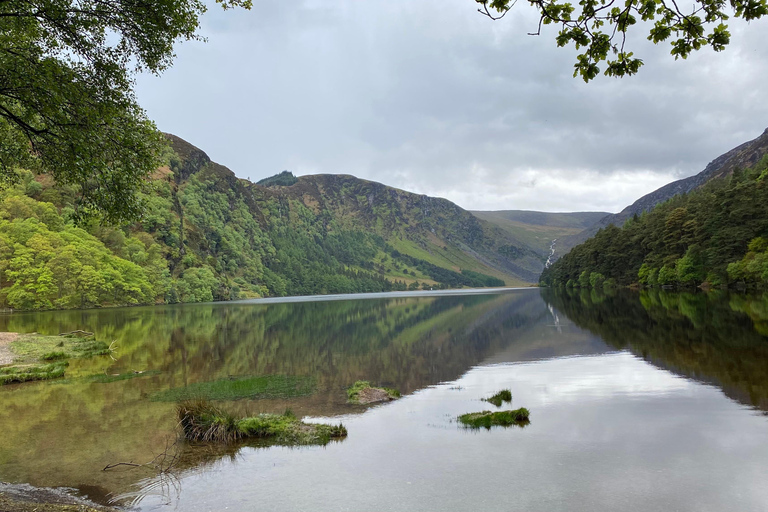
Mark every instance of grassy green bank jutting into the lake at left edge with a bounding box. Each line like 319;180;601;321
0;334;110;385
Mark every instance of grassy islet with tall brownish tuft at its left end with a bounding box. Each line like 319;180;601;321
177;400;347;446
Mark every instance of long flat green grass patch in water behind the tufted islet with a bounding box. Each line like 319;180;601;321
152;375;316;402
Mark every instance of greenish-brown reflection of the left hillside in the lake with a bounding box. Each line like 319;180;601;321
0;290;548;498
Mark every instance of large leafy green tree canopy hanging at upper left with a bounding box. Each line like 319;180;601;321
0;0;251;222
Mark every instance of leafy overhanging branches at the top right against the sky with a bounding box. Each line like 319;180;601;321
476;0;768;82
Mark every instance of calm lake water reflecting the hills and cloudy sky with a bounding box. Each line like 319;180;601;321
0;289;768;512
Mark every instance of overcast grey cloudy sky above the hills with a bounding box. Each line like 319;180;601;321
137;0;768;212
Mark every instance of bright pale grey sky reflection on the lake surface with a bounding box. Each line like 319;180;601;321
135;292;768;512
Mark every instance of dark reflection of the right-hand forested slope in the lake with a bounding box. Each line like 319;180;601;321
542;289;768;411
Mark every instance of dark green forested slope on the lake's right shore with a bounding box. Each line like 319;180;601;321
541;156;768;288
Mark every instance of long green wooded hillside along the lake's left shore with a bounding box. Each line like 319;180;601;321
0;135;542;309
